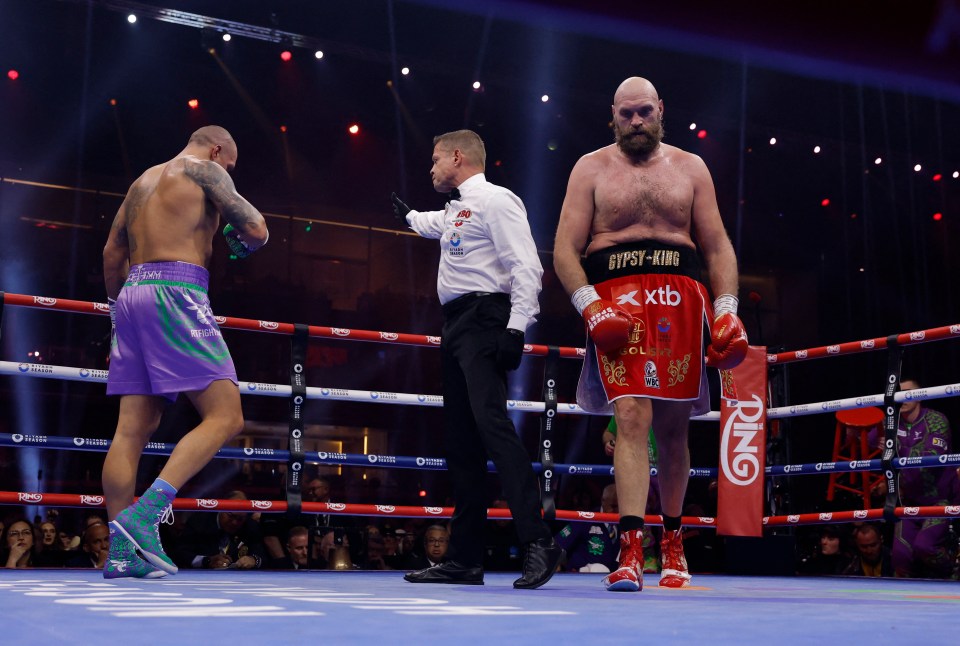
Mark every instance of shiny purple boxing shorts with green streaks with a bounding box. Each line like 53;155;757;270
107;262;237;400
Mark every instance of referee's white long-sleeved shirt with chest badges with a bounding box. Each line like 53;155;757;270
407;173;543;331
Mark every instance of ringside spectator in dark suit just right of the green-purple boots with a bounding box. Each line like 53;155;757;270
174;491;264;570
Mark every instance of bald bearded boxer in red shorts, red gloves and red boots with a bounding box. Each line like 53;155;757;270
554;77;747;591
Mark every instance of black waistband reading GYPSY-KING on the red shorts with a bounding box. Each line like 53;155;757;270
583;240;700;283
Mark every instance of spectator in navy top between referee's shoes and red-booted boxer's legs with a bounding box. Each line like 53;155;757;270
556;484;620;572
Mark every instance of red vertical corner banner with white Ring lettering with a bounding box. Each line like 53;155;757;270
717;346;767;536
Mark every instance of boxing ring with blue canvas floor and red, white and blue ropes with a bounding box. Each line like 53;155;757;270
0;293;960;643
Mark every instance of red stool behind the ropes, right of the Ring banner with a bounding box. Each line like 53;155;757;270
827;407;884;509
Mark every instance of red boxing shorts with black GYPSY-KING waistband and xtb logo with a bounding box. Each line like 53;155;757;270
577;240;712;415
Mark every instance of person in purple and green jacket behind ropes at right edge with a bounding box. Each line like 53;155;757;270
891;379;960;579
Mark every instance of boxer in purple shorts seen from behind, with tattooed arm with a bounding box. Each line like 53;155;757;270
103;126;269;579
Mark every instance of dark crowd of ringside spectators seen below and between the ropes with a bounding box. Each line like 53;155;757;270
0;422;960;580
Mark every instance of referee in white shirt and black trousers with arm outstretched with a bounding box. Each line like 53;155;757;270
391;130;563;589
